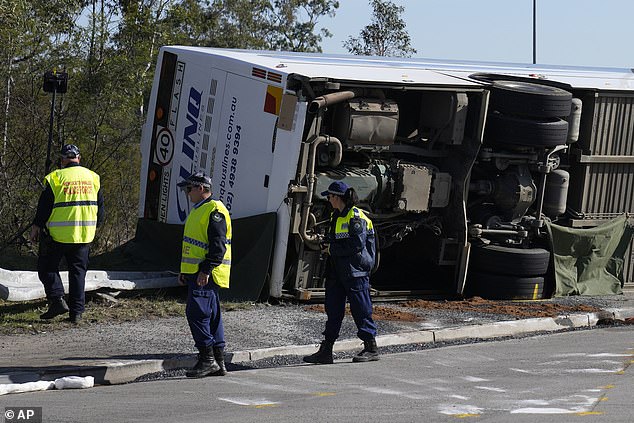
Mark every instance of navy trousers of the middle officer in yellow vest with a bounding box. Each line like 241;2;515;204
185;273;225;348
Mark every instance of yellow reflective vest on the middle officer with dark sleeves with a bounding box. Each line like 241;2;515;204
181;200;231;288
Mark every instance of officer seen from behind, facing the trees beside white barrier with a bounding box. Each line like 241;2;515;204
30;144;105;324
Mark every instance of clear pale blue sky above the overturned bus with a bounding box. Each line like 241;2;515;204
319;0;634;68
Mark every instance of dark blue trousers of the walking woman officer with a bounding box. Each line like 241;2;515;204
324;276;376;342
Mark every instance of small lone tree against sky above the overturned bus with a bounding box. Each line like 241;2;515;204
343;0;416;57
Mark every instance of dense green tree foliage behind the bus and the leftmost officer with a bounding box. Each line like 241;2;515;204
0;0;339;267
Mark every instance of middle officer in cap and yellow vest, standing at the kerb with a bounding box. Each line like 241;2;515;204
177;172;231;377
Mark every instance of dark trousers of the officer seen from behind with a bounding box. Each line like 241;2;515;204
37;238;90;315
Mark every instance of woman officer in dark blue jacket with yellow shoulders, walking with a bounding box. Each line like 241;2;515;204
304;181;379;364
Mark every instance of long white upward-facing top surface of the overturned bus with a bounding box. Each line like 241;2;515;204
164;46;634;91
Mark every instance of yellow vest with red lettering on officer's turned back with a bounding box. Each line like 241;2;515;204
44;166;101;244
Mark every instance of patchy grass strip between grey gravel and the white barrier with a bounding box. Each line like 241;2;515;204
0;287;253;335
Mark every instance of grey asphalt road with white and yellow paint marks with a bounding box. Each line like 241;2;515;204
0;326;634;423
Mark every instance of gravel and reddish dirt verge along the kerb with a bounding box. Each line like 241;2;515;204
0;296;634;377
